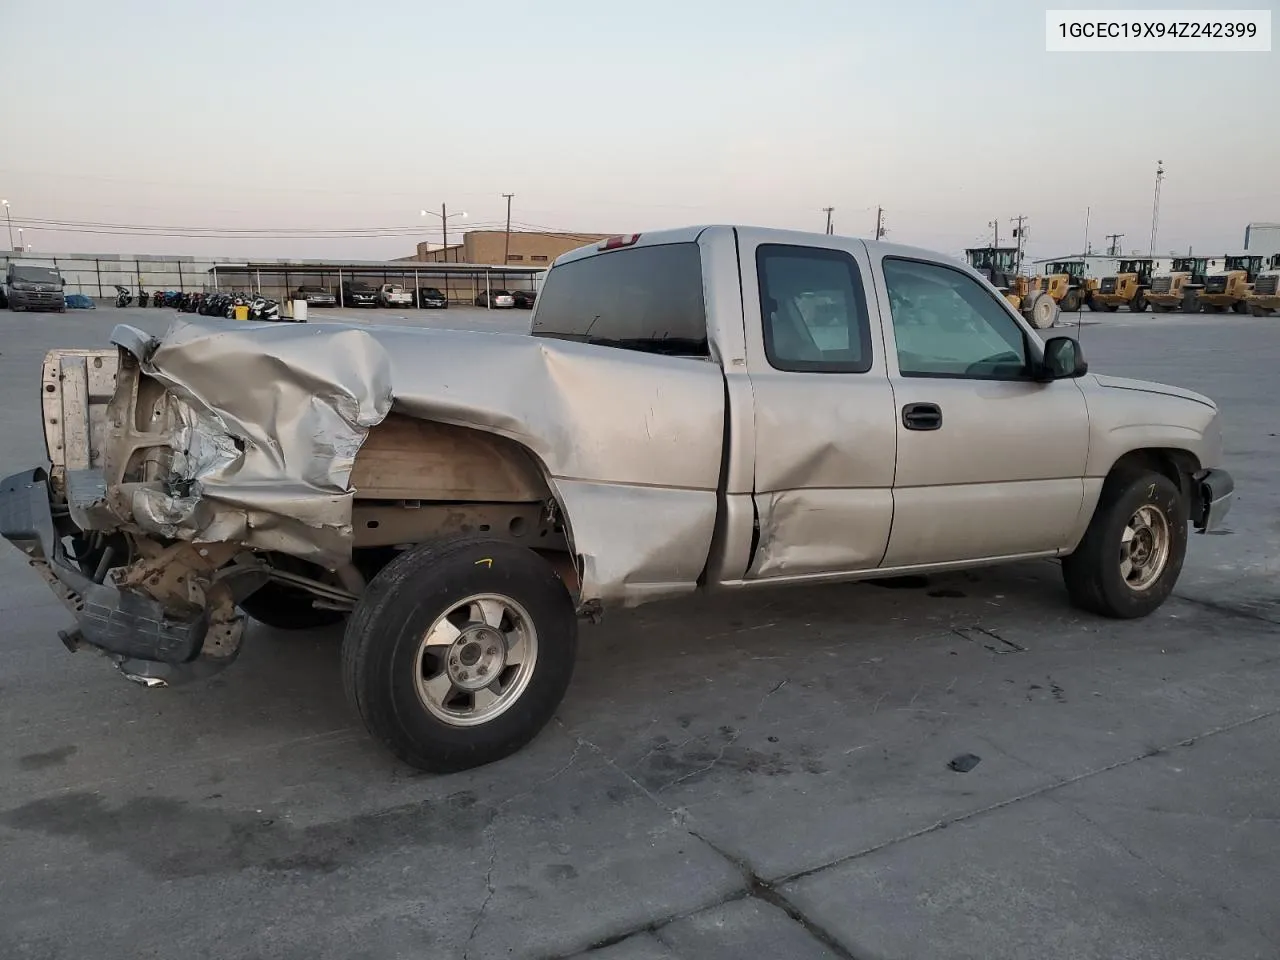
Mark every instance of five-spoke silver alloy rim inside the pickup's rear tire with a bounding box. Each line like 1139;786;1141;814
416;594;538;727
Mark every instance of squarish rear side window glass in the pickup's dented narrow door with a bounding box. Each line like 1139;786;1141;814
755;243;872;374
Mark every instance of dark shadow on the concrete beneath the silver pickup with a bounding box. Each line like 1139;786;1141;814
217;561;1080;757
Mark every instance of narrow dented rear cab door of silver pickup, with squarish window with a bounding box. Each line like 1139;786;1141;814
739;229;897;580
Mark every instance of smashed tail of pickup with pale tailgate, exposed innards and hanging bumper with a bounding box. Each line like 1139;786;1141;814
0;339;270;686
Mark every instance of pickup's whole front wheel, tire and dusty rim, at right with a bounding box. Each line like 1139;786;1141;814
1062;470;1189;620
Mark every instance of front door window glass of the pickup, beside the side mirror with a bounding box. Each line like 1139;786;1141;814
882;257;1027;380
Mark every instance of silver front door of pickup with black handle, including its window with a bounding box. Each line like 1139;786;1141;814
876;255;1089;567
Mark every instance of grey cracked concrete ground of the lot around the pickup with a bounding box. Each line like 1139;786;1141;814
0;307;1280;960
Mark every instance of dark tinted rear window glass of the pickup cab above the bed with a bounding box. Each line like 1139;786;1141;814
532;243;709;357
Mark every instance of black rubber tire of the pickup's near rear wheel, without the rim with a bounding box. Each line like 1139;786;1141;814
342;536;577;773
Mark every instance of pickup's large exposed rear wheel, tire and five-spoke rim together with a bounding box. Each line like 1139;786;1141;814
342;538;577;773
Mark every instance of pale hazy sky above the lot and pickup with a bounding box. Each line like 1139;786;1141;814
0;0;1280;259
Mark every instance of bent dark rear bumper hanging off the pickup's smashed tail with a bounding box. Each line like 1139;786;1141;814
0;468;232;685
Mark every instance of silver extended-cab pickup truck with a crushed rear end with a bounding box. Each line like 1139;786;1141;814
0;227;1233;771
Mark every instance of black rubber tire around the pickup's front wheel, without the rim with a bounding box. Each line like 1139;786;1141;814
1062;467;1188;620
